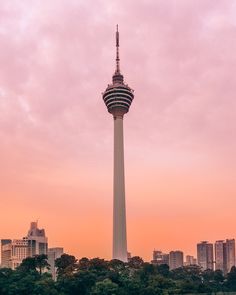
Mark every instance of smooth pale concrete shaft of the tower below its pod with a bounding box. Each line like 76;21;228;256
113;115;127;261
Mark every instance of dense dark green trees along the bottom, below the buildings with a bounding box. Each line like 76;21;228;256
0;254;236;295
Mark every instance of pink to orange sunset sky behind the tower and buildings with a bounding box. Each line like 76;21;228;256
0;0;236;260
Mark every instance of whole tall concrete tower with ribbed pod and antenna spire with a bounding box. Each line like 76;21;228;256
103;25;134;261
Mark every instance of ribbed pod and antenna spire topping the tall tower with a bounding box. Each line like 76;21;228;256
103;25;134;116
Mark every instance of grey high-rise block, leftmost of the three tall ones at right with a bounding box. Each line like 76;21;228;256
197;241;214;270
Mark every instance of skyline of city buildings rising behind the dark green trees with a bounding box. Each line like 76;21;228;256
0;221;236;268
